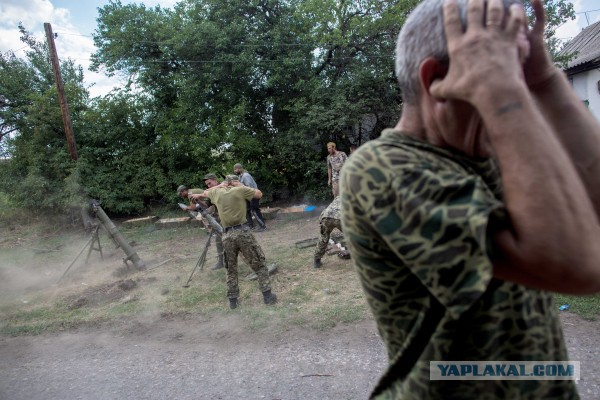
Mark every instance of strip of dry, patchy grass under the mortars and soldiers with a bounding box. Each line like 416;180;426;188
0;212;369;335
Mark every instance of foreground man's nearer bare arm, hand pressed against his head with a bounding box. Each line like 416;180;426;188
431;0;600;294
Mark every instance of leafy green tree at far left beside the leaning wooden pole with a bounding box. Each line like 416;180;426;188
0;26;88;209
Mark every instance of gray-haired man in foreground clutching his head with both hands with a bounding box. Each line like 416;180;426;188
340;0;600;399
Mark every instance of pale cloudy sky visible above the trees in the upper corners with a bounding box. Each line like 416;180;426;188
0;0;600;96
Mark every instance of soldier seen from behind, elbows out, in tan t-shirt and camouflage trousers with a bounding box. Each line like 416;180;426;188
189;175;277;309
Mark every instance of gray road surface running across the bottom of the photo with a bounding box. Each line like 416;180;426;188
0;313;600;400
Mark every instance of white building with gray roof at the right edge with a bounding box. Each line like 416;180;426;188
560;22;600;121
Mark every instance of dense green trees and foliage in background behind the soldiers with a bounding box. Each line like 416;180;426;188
0;0;574;214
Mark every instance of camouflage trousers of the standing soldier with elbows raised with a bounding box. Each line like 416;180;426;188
223;230;271;299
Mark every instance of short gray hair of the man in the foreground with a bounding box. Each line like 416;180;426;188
396;0;521;105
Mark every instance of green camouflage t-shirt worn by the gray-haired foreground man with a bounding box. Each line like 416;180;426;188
340;129;579;400
